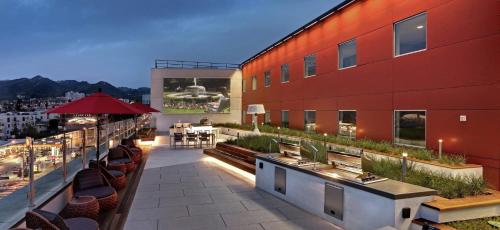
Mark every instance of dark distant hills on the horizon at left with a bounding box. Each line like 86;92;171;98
0;76;150;100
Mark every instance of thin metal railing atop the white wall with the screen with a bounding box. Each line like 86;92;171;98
155;59;240;69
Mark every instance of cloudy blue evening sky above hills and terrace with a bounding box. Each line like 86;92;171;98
0;0;339;88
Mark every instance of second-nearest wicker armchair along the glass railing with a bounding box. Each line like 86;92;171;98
73;168;118;211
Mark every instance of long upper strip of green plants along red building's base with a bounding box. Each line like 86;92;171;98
216;123;465;165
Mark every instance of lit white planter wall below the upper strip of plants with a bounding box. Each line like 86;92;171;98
220;127;483;177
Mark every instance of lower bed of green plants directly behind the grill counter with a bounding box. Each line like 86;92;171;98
364;159;487;199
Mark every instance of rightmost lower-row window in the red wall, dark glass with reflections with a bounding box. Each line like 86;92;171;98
394;111;426;147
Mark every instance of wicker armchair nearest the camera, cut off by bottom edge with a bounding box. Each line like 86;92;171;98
25;209;99;230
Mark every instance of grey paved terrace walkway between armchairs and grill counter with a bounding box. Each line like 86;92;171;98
125;137;338;230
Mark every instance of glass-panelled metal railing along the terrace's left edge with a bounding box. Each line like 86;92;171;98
0;116;149;229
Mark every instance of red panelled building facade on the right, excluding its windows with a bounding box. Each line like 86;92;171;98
242;0;500;189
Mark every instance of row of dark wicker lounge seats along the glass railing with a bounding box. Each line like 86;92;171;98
14;139;143;230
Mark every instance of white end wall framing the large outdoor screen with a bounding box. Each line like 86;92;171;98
151;68;242;132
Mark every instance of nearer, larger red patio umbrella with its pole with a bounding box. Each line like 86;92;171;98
47;90;144;161
